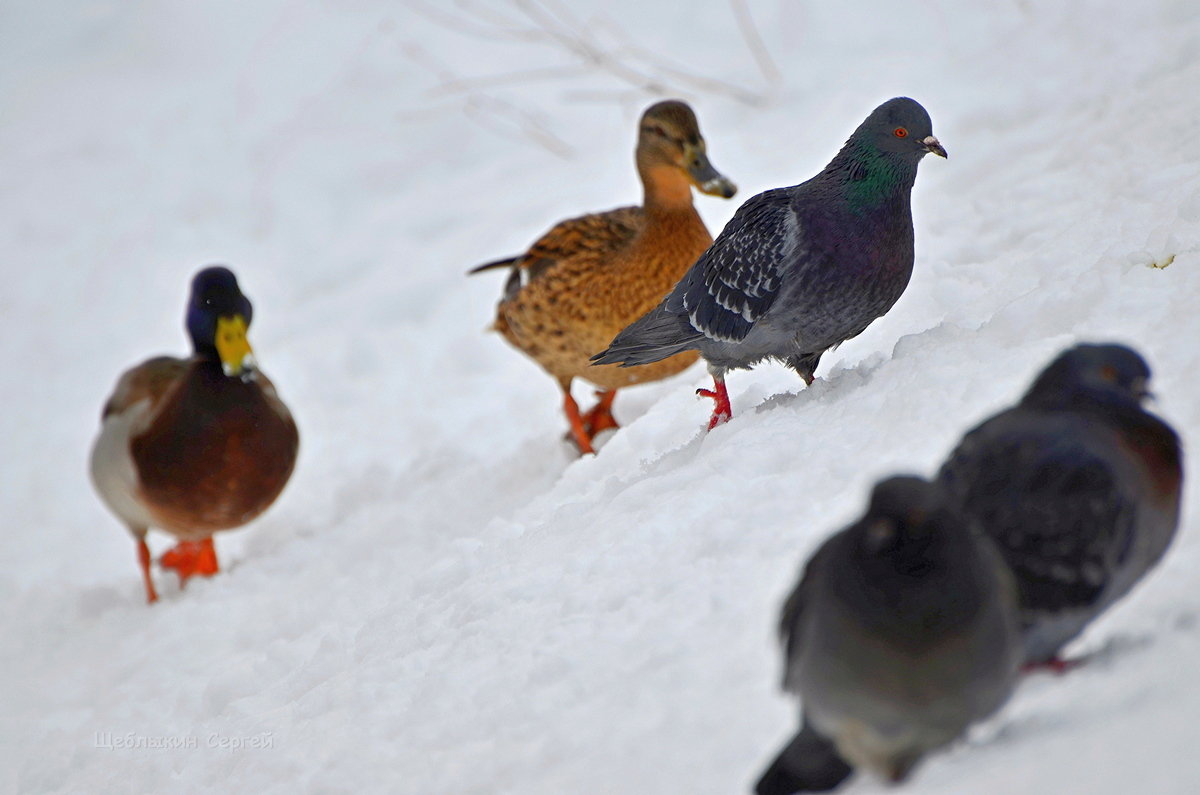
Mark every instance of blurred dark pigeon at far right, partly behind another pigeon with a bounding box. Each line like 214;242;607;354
938;345;1183;670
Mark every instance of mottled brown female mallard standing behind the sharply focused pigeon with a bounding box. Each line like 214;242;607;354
470;100;737;453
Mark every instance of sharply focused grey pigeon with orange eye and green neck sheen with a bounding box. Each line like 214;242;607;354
593;97;946;429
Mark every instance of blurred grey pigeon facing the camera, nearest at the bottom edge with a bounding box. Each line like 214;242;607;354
755;477;1020;795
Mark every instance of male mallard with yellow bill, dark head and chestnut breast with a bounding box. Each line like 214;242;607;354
91;268;300;602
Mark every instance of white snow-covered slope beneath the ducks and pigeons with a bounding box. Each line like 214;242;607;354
0;0;1200;795
